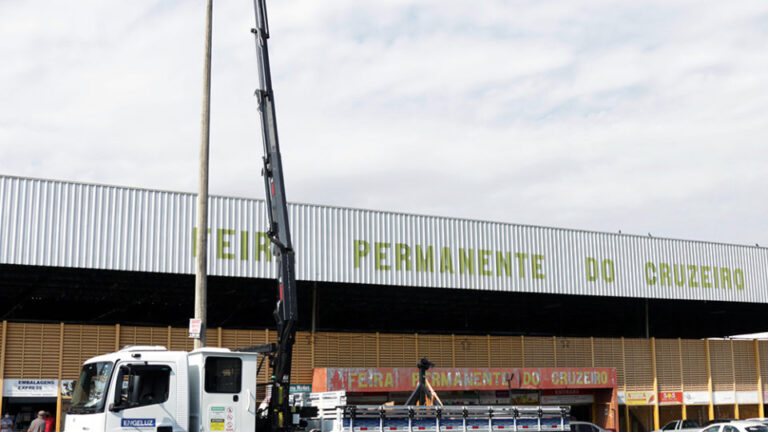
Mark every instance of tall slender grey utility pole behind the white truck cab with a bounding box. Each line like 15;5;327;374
194;0;213;349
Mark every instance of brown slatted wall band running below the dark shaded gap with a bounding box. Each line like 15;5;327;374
0;323;768;398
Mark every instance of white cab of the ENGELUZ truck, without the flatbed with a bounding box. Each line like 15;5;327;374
64;346;258;432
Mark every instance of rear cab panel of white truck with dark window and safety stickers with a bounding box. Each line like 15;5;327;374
200;355;256;432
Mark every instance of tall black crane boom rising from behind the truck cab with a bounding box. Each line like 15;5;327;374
252;0;298;432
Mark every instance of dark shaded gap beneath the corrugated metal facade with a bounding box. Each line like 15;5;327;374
0;265;768;338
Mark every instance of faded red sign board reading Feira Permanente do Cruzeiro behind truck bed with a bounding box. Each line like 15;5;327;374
312;368;616;393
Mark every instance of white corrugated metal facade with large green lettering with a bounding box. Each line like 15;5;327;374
0;176;768;303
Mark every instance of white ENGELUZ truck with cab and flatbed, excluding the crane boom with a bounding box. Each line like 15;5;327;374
64;346;570;432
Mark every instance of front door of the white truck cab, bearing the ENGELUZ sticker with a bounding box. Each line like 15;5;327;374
105;362;180;432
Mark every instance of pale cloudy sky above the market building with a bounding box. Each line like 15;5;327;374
0;0;768;245
